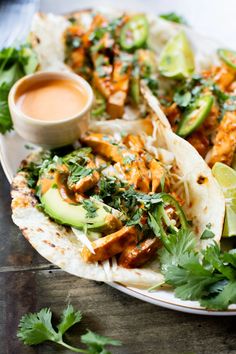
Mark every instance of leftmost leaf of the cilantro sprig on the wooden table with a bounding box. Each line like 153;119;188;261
17;308;58;345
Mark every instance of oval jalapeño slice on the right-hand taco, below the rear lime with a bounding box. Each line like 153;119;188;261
176;95;214;138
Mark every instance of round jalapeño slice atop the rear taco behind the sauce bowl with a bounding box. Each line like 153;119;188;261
120;15;148;51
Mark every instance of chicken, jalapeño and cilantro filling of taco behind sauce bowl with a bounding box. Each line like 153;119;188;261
64;11;157;119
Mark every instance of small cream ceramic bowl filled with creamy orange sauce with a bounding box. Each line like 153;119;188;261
8;72;93;148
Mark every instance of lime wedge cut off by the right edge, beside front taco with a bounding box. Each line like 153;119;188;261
212;162;236;237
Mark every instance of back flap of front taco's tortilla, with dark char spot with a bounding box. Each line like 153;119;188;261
92;116;225;248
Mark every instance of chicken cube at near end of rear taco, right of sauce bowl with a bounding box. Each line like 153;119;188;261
107;91;127;119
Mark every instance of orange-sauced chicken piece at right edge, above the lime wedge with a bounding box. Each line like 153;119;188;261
207;112;236;167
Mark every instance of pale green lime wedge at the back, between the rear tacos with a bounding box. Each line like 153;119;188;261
159;31;194;79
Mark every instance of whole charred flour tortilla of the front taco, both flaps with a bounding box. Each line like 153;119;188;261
12;115;225;288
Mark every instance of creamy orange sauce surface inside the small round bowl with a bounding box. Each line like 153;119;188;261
16;79;88;121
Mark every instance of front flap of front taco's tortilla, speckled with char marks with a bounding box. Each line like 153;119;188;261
11;172;163;288
